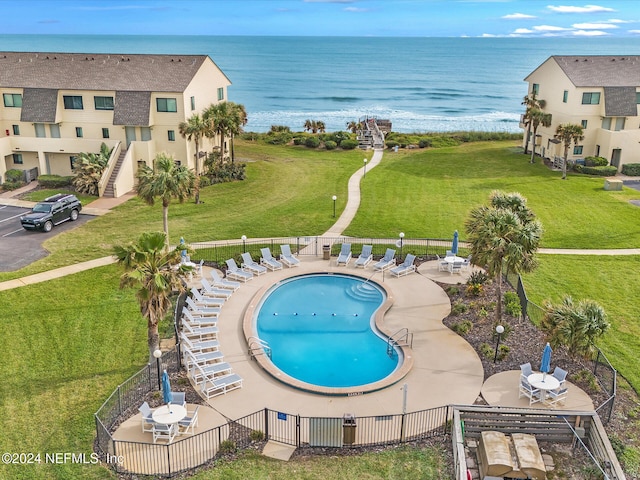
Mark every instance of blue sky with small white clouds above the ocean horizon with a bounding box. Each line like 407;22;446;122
0;0;640;39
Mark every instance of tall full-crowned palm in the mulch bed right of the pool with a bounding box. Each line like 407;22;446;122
465;191;542;323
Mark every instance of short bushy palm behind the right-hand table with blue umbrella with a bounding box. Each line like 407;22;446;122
541;296;611;357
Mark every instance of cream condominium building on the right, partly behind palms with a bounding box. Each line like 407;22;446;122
523;55;640;169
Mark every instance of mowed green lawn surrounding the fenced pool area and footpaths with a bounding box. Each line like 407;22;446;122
0;138;640;479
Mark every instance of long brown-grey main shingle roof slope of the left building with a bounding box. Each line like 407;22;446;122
0;52;208;92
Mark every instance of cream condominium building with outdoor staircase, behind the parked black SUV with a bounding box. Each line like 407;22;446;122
0;52;231;196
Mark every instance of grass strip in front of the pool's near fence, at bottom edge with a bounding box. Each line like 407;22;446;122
188;447;454;480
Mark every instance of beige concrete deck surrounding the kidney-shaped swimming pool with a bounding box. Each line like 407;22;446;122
194;257;484;419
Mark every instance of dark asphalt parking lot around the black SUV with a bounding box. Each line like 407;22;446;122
0;205;93;272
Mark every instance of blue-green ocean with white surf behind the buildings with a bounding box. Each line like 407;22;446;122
0;35;640;133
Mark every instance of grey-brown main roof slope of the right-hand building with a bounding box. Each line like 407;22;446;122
551;55;640;87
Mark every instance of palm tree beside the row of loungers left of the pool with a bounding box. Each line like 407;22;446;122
114;232;192;359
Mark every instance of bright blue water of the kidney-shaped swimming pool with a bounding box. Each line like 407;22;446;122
256;274;399;387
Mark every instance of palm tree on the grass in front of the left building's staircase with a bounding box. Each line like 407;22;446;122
136;153;197;247
